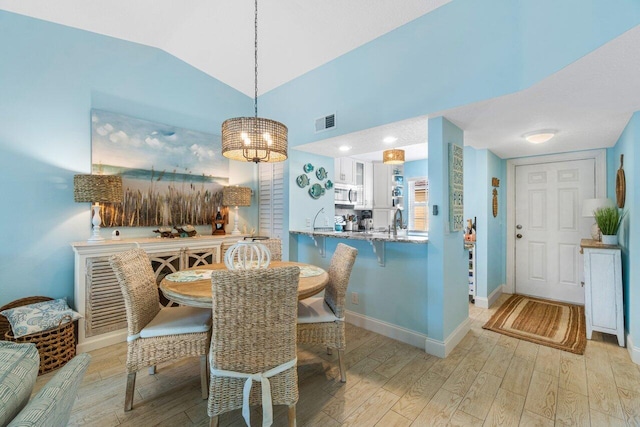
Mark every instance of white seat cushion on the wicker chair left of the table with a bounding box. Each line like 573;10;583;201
140;307;211;338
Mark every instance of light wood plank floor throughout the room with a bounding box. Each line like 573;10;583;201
36;296;640;427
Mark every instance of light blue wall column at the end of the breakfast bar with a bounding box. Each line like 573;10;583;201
426;117;469;342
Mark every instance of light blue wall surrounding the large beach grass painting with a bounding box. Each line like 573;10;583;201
0;11;255;305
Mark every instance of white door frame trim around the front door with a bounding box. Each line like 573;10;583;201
504;149;607;294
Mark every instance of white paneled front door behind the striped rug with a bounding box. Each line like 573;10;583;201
512;159;595;304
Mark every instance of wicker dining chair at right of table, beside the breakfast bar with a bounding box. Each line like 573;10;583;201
298;243;358;383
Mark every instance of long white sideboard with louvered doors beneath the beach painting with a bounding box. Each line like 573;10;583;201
71;235;243;353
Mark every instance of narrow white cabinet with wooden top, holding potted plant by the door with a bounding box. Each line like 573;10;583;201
580;239;624;347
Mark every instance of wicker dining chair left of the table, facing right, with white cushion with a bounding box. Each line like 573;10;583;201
109;249;211;411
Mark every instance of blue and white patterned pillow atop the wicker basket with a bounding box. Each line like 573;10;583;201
0;299;82;339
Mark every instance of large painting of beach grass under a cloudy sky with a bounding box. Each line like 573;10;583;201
91;110;229;227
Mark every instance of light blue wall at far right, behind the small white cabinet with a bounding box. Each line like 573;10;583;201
607;112;640;347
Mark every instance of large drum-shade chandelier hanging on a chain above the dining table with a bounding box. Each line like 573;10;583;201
222;0;287;163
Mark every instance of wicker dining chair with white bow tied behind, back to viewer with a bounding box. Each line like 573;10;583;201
207;267;300;426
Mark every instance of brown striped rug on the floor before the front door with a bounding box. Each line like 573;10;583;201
483;295;587;354
